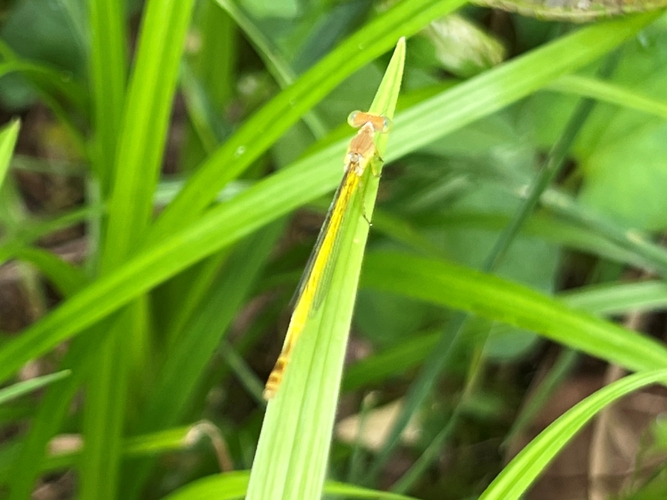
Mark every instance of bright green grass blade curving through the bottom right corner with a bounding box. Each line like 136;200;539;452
479;370;667;500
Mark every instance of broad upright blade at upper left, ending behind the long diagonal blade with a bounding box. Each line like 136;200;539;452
103;0;194;269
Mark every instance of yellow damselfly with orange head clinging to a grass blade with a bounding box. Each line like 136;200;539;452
264;111;391;400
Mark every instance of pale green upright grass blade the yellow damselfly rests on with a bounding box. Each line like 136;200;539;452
247;39;405;500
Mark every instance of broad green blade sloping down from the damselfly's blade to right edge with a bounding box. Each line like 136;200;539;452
362;253;667;370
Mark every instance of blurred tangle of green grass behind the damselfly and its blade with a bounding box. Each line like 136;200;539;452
0;0;667;499
